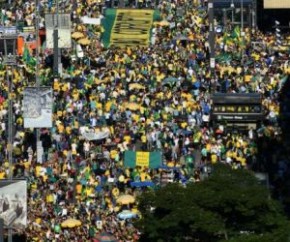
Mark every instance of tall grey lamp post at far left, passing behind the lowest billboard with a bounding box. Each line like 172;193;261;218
0;26;18;242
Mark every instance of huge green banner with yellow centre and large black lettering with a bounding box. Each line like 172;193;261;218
102;9;159;47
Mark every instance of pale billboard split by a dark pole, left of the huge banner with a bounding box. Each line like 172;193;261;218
45;14;71;49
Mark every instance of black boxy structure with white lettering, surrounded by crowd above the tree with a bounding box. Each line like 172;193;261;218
211;93;265;128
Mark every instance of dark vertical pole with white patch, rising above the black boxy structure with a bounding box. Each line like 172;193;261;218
208;0;215;91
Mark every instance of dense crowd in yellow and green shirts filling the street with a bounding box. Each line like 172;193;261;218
0;0;289;241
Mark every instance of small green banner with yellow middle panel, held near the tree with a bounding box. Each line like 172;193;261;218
124;151;162;169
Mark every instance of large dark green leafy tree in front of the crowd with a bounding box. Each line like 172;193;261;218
136;165;290;242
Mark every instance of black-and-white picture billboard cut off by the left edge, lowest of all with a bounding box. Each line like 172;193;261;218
0;180;27;229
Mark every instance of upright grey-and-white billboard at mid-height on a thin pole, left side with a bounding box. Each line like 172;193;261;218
22;87;53;128
